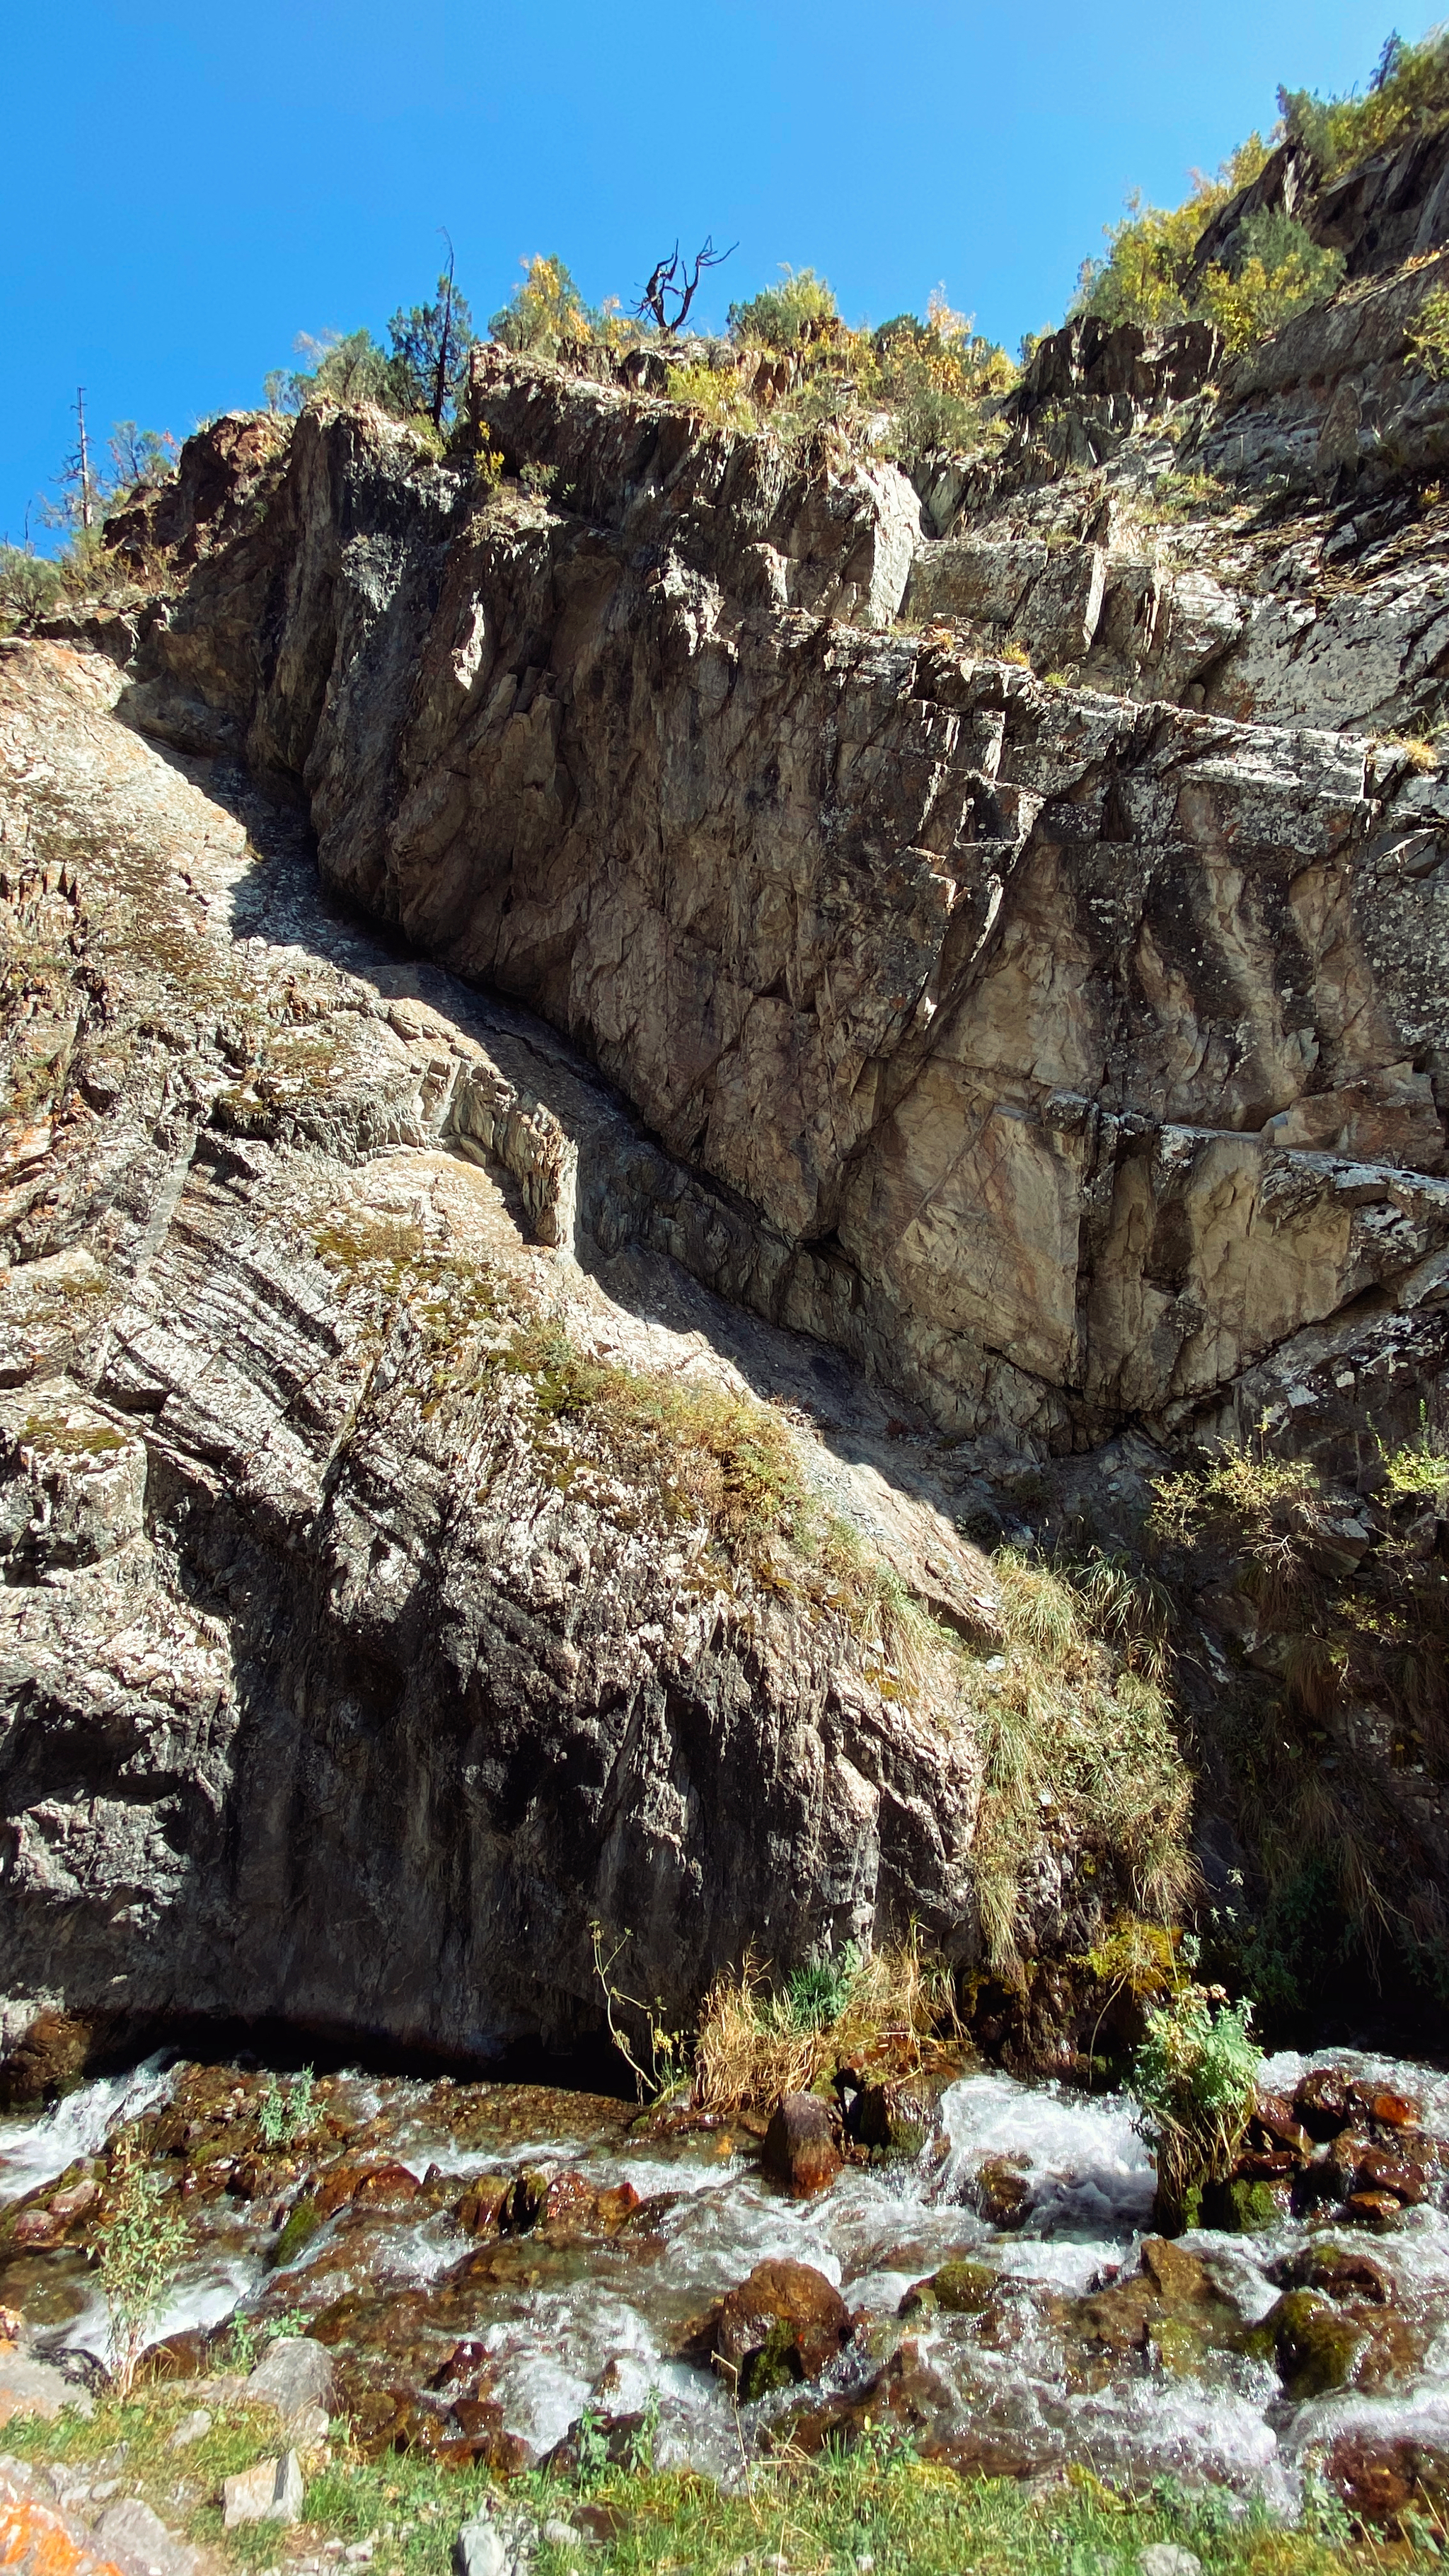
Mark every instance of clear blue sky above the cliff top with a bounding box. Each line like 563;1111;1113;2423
0;0;1402;541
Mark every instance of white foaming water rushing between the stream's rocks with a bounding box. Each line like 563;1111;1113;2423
0;2050;1449;2509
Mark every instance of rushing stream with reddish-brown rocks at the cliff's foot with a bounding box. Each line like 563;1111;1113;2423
0;2050;1449;2512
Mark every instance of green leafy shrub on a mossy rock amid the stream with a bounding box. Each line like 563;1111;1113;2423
1132;1984;1264;2226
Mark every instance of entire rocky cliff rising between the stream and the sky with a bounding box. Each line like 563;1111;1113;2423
0;156;1449;2050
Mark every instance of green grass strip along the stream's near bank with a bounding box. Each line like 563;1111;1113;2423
5;2380;1371;2576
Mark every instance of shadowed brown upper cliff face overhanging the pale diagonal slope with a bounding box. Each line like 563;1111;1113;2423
132;353;1449;1448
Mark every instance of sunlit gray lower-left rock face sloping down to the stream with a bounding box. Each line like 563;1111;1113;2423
0;647;995;2050
